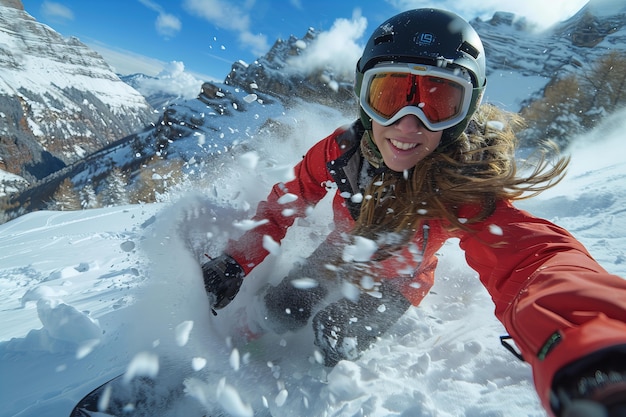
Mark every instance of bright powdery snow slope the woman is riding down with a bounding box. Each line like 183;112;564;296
0;102;626;417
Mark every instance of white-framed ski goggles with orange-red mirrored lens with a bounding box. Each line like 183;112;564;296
359;64;473;131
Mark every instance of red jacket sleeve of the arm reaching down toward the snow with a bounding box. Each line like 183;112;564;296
225;129;341;275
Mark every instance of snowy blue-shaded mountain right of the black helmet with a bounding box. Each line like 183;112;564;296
471;0;626;112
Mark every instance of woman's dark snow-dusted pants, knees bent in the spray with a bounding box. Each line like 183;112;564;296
265;244;411;366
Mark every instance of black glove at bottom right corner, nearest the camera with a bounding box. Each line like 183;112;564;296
552;346;626;417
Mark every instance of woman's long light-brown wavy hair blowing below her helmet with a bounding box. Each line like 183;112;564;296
353;104;569;245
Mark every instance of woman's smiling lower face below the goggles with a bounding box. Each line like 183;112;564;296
372;115;443;172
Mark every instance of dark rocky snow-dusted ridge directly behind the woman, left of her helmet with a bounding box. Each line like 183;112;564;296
0;23;356;218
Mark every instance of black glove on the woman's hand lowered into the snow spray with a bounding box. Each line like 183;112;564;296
202;255;245;315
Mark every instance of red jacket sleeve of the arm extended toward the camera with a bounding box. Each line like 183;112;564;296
460;198;626;410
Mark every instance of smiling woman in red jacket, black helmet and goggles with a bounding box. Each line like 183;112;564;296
203;9;626;416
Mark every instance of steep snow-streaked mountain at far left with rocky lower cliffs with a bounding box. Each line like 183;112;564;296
0;0;157;182
